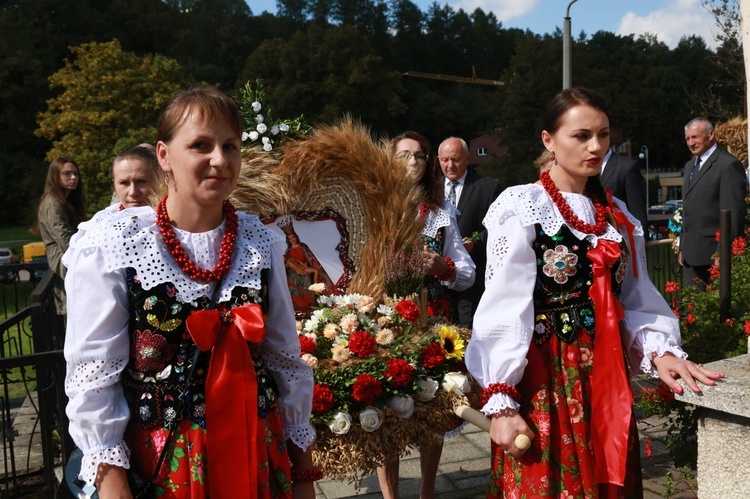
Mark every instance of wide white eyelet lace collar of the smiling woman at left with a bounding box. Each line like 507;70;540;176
70;207;281;303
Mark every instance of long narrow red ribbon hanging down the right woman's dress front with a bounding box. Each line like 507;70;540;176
587;239;633;485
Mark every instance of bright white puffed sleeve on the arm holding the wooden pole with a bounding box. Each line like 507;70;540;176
466;216;537;415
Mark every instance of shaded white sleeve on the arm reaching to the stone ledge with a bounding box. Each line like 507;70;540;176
620;204;687;376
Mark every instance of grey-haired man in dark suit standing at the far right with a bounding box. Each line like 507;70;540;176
678;118;747;288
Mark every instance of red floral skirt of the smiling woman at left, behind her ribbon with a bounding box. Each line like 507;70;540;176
126;410;292;499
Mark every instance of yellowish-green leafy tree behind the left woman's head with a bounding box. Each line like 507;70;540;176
35;40;188;209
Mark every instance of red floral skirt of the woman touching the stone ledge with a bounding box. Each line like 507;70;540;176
488;331;643;499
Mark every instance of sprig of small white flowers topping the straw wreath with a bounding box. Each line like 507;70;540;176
235;80;312;152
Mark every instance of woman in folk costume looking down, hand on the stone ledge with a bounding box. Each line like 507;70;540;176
466;89;723;498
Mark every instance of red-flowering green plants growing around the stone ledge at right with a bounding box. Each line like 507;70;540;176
636;229;750;469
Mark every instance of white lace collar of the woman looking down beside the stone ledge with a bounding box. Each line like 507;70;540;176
484;184;643;246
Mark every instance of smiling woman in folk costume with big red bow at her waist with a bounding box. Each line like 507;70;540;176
65;87;317;499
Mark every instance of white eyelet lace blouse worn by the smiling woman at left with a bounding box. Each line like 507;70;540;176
63;207;315;484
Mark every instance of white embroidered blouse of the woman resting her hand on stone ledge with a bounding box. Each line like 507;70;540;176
466;184;687;415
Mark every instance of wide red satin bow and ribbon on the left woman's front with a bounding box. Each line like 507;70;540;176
186;303;265;499
